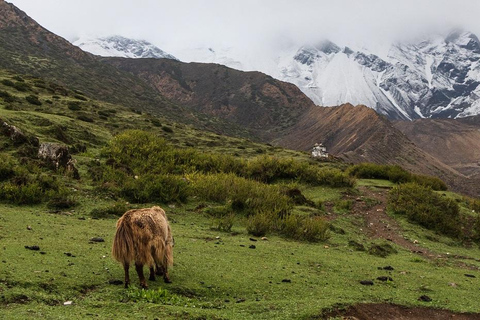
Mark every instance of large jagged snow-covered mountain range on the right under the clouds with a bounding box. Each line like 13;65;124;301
173;31;480;120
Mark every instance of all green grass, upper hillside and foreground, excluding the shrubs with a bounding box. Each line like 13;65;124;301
0;71;480;319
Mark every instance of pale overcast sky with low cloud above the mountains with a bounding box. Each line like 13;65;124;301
8;0;480;51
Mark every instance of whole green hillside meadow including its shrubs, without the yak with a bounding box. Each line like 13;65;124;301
0;71;480;319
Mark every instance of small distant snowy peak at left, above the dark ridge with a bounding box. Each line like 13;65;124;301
73;36;178;60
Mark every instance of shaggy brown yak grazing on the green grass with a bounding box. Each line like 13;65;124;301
112;207;173;288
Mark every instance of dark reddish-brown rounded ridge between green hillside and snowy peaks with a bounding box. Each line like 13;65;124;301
103;58;314;141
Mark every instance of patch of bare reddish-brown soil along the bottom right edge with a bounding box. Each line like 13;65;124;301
318;304;480;320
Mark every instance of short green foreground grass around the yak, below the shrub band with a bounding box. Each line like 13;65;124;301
0;201;479;319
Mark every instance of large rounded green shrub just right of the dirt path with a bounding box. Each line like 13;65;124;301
388;183;462;237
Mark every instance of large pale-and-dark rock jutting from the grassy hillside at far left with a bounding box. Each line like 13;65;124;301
38;142;80;179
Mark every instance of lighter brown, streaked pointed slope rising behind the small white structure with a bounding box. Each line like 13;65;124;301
276;104;472;194
